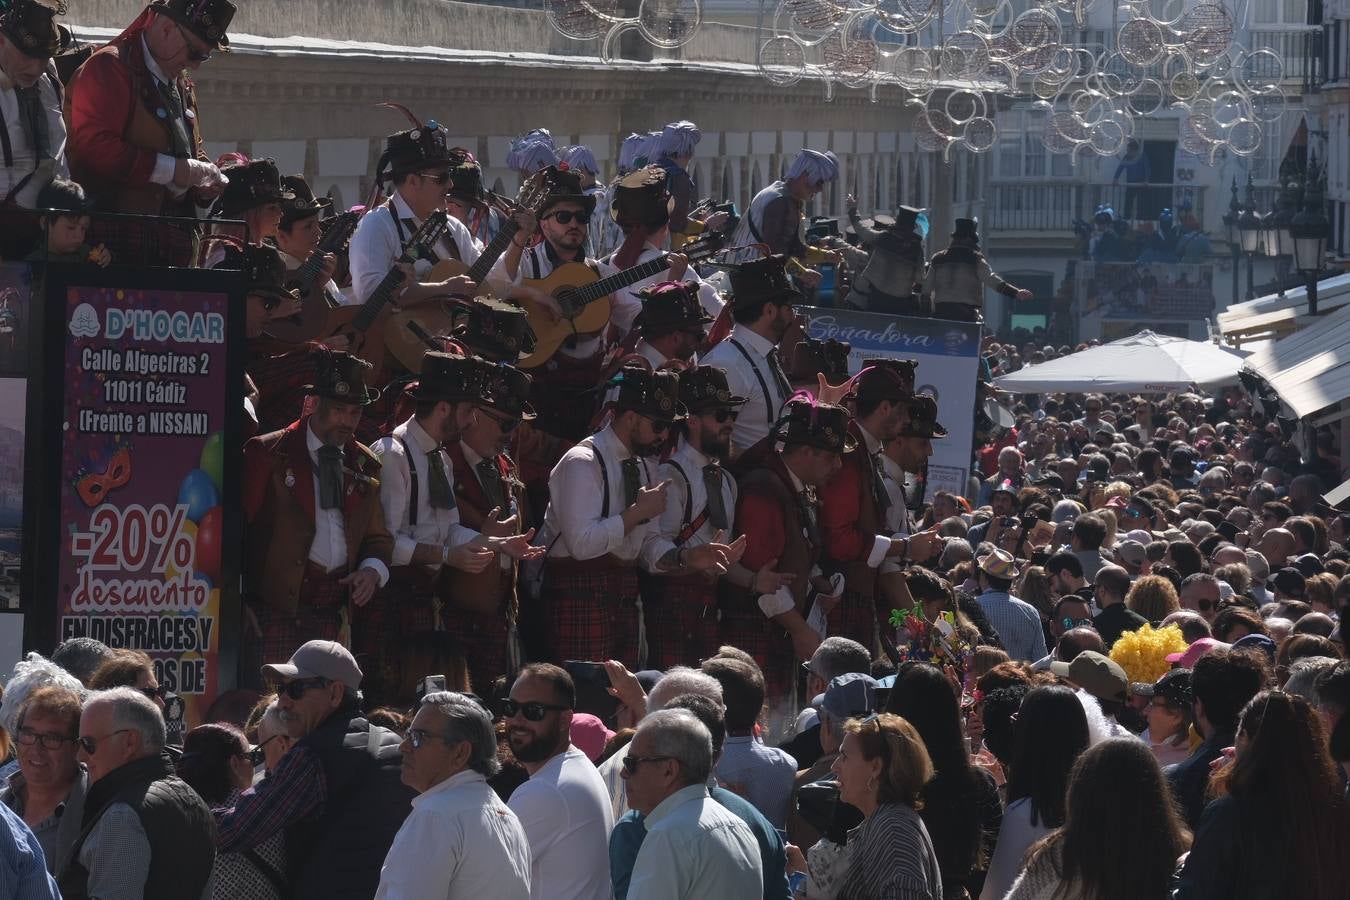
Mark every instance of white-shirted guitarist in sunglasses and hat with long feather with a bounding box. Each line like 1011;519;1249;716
347;120;483;306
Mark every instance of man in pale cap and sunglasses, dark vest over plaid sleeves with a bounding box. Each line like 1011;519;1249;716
215;641;413;900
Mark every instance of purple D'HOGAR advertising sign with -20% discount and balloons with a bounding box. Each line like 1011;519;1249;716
46;282;239;726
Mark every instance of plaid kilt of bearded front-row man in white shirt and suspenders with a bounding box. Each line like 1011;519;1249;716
639;572;720;671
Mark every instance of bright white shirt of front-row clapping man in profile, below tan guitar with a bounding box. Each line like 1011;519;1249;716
540;426;656;560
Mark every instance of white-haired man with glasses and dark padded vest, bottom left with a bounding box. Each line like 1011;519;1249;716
57;687;216;900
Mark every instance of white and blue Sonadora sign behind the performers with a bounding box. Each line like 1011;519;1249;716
801;306;980;498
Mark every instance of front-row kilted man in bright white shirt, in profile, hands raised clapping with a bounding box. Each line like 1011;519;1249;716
539;364;686;669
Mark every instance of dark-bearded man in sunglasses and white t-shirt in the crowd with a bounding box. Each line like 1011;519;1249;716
502;663;614;900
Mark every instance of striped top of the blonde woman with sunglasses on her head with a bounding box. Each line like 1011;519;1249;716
838;803;942;900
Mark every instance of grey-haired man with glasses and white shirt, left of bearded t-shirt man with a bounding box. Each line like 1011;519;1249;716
375;691;529;900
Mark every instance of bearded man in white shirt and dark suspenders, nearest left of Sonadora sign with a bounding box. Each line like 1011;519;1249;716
699;256;802;452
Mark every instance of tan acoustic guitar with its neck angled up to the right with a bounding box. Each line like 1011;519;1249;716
512;231;726;368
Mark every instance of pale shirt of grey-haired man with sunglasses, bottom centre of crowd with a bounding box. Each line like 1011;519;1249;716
628;784;764;900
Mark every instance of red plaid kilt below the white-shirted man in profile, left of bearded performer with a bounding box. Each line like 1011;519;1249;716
543;559;640;672
